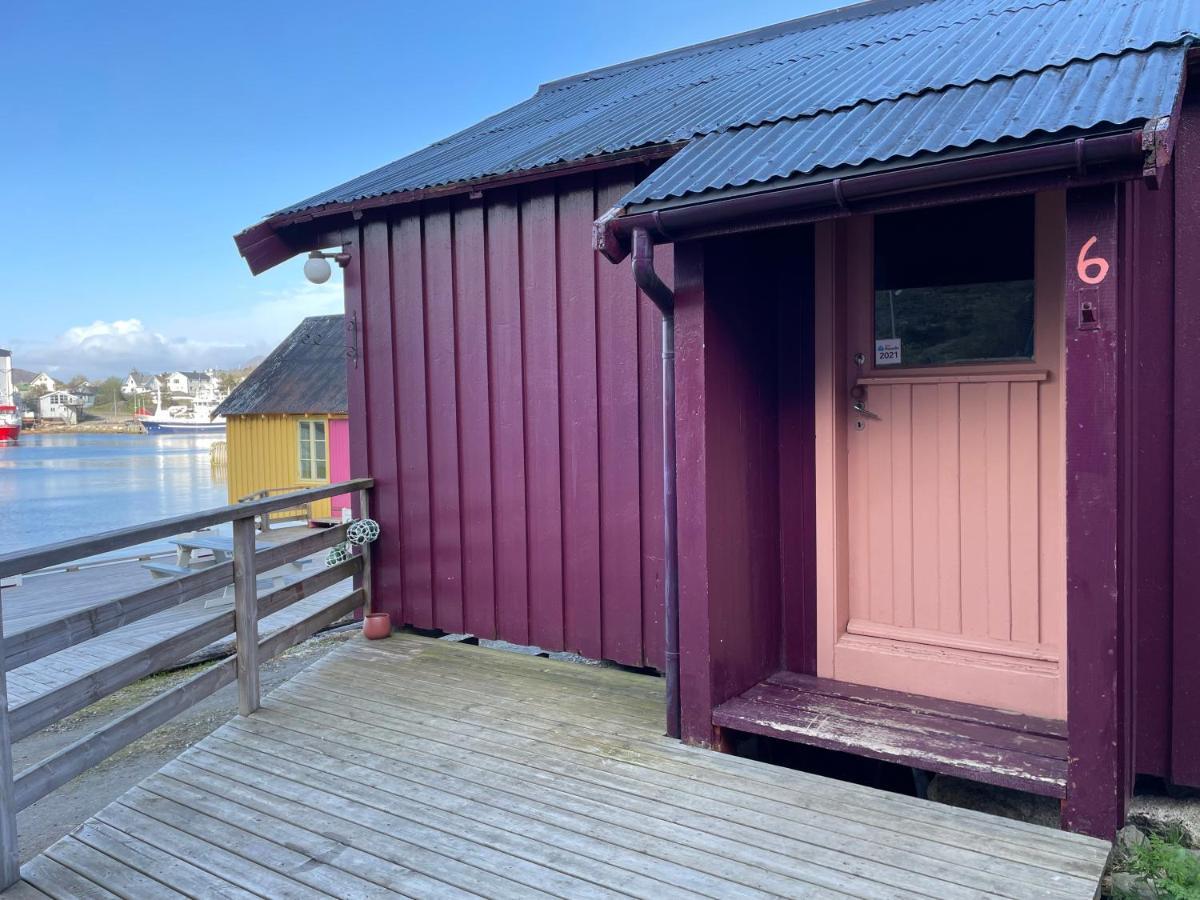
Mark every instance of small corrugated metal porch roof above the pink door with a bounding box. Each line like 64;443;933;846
620;47;1187;205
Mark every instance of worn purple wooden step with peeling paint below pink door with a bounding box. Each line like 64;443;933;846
713;672;1067;797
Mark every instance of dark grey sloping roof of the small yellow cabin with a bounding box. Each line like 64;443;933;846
215;316;348;415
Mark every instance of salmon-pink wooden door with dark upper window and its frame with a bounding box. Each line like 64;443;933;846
817;194;1066;718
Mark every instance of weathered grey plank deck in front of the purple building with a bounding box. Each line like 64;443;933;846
6;635;1108;900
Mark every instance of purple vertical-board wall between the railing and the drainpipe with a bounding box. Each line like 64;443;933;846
346;169;672;666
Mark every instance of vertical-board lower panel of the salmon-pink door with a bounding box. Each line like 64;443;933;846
851;374;1062;652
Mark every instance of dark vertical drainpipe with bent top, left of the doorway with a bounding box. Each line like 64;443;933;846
632;228;680;738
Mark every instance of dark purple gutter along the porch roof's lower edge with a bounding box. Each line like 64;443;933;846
593;125;1156;263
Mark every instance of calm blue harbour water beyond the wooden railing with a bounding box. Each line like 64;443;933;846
0;432;227;556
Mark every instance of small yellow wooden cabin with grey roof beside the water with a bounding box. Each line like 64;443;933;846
217;316;349;523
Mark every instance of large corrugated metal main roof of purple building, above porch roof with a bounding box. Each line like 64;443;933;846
276;0;1200;215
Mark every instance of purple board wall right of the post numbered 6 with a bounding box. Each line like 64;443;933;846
1126;88;1200;786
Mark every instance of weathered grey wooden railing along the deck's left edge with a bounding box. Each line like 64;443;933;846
0;479;372;890
